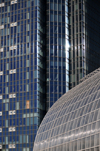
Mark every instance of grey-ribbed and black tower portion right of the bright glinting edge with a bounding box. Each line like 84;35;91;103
69;0;100;88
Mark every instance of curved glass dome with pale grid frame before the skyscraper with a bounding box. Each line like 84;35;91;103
33;69;100;151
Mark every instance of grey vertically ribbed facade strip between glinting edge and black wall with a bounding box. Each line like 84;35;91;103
69;0;86;88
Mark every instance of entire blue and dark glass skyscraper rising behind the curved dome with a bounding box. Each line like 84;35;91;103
0;0;100;151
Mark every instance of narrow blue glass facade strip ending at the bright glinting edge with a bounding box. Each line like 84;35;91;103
46;0;69;110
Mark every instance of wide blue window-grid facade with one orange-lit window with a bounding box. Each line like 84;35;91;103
0;0;45;151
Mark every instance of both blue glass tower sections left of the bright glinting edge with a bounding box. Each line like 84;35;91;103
0;0;69;151
